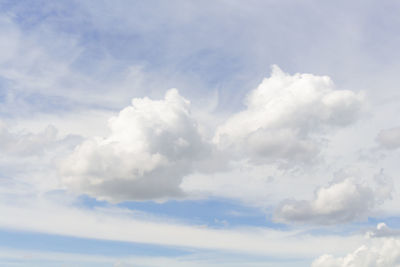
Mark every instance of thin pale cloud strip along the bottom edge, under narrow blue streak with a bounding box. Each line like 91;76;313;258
0;250;299;267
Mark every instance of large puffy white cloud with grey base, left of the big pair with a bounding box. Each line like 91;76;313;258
62;89;207;201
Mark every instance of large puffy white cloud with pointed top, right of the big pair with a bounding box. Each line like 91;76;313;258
214;66;363;165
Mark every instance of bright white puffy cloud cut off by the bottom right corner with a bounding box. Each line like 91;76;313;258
311;238;400;267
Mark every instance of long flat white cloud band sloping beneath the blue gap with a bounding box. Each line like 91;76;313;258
0;195;364;259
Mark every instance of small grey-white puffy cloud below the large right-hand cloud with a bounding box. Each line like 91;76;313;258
274;179;392;224
